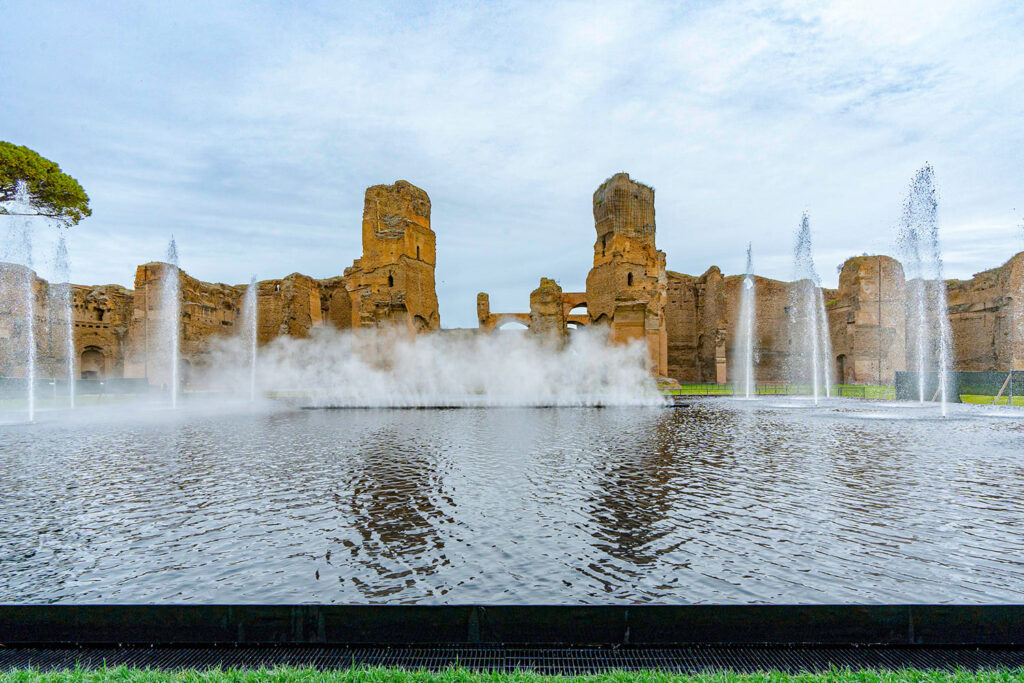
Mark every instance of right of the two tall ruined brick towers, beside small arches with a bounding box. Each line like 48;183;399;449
587;173;669;376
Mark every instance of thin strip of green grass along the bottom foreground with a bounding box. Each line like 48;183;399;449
0;667;1024;683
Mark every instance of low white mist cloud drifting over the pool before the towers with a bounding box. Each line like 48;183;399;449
197;329;664;408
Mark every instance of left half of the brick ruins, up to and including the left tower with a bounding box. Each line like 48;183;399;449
0;180;440;386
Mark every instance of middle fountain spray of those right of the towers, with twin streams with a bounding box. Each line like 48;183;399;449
791;212;833;404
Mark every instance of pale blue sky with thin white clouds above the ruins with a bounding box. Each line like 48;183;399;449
0;0;1024;328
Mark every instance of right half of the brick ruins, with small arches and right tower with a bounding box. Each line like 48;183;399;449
477;173;1024;384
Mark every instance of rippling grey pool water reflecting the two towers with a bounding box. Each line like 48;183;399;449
0;399;1024;603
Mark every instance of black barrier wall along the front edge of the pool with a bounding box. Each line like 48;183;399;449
0;605;1024;646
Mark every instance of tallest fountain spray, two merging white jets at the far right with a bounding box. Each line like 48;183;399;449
897;164;952;417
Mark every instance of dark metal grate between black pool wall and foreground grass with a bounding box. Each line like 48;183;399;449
0;646;1024;676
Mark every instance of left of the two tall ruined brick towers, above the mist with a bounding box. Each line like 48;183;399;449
345;180;440;332
